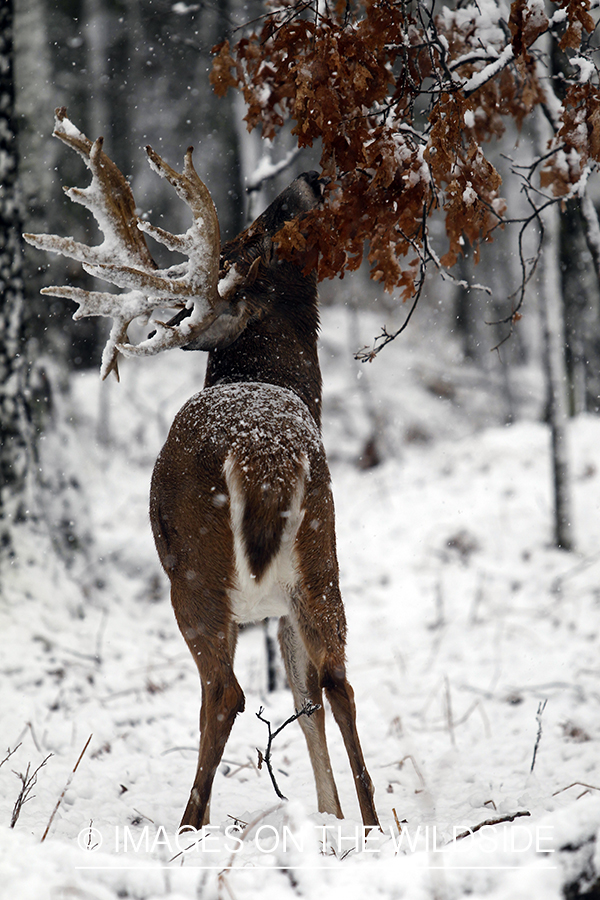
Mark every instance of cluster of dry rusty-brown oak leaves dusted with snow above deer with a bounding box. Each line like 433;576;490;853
211;0;600;299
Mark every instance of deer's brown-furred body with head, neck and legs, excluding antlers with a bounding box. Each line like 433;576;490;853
150;173;378;828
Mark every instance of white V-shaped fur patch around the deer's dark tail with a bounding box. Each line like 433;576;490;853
223;451;309;624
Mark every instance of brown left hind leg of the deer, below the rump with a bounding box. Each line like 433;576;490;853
172;586;244;828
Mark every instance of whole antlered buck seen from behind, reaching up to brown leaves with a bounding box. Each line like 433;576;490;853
25;108;379;829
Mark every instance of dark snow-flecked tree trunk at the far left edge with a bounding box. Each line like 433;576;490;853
0;0;30;555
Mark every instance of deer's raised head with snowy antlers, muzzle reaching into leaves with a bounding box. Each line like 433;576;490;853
24;107;322;379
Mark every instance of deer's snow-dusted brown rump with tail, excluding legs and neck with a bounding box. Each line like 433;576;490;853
150;383;344;640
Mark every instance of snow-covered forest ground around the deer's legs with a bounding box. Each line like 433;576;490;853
0;309;600;900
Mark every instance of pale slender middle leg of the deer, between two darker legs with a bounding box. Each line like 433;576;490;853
279;616;343;819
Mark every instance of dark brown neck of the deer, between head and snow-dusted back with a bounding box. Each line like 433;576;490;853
204;298;321;428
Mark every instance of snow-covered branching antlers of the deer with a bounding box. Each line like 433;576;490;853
24;107;229;379
